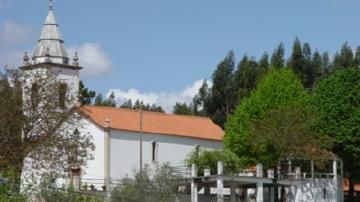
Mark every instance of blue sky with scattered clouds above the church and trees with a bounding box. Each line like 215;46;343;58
0;0;360;111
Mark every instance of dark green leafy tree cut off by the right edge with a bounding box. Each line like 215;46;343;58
312;68;360;200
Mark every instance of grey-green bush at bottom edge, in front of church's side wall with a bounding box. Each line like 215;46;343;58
111;164;179;202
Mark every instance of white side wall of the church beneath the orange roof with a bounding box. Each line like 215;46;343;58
110;130;223;181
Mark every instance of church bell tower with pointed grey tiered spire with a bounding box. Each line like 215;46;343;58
20;0;82;107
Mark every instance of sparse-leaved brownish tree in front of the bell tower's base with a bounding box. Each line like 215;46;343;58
0;71;94;189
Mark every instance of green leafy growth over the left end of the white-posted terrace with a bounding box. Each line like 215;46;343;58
185;149;241;176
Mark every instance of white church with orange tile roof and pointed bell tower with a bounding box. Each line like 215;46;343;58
20;3;224;191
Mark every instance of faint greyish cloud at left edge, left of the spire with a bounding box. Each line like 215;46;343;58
0;20;33;46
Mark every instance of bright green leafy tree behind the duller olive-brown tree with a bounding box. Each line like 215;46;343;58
224;69;308;166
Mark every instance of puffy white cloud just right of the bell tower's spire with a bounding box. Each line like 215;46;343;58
68;43;112;76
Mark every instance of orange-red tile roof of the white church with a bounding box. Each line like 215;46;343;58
80;106;224;141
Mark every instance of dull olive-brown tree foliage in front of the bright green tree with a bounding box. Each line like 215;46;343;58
249;104;331;168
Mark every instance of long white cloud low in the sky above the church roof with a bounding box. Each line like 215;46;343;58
107;80;207;113
